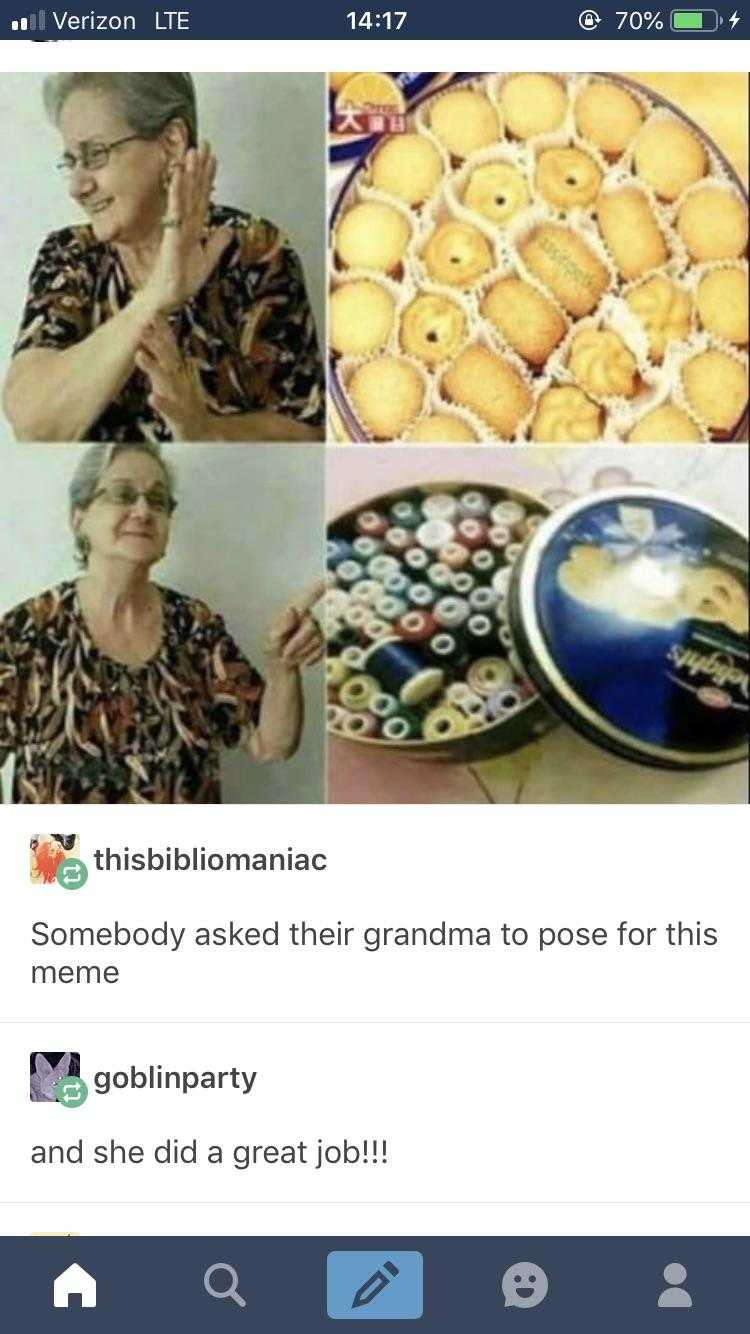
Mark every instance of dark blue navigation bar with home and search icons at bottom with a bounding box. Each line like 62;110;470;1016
0;1232;750;1334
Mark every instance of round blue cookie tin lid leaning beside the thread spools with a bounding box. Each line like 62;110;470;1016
510;487;749;768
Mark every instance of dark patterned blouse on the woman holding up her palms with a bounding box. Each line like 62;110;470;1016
13;205;324;442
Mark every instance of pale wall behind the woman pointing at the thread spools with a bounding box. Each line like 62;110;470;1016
0;444;324;802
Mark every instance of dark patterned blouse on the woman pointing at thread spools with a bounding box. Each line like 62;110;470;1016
0;580;263;803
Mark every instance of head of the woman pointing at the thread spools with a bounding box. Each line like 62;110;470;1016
72;450;172;566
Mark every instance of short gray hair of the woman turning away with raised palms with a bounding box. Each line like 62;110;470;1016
43;73;198;148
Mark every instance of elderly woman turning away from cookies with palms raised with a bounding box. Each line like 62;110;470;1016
4;73;324;442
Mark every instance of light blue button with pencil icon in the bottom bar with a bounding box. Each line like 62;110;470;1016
326;1250;424;1321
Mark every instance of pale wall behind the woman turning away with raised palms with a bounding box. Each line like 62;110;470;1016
0;73;326;421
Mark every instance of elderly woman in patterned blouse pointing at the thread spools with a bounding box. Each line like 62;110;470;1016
0;442;324;803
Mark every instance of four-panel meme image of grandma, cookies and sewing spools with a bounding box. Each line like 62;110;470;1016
0;71;750;804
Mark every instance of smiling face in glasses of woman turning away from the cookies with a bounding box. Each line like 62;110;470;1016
59;88;165;244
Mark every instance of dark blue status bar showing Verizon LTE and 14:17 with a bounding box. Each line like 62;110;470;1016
0;0;750;40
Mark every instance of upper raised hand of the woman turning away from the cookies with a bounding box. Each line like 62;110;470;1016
144;143;232;315
